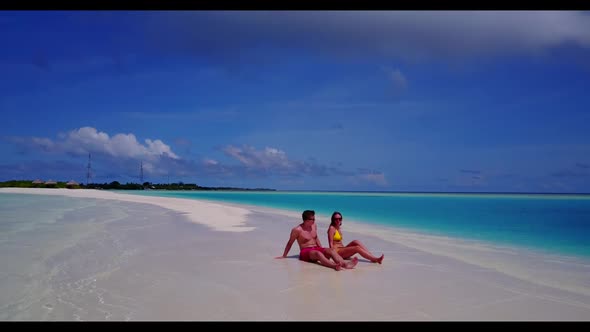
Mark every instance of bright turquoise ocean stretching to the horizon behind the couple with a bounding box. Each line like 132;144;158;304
120;190;590;258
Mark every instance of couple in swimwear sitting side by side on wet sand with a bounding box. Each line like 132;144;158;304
276;210;384;271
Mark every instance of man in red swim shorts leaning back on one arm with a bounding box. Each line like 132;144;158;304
276;210;358;271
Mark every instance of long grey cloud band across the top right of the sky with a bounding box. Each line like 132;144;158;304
151;11;590;62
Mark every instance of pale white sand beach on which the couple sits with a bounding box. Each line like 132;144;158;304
0;188;590;321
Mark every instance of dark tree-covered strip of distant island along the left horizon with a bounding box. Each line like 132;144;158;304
0;180;276;191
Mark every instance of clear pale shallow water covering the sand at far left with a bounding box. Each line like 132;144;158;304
0;194;186;320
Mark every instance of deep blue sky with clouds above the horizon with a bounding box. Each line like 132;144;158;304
0;11;590;193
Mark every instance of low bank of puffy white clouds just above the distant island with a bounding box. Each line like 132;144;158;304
12;127;394;186
